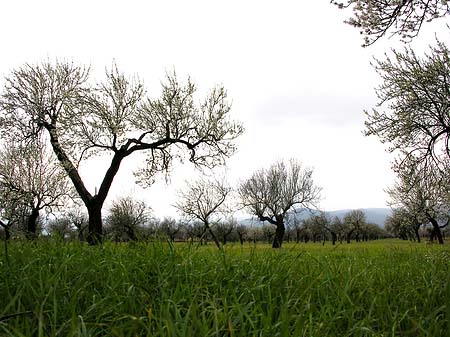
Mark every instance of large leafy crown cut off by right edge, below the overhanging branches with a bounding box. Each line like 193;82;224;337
365;42;450;168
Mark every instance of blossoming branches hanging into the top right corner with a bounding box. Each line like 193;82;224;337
330;0;450;46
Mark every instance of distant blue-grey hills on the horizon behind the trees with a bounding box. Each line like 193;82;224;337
238;208;392;228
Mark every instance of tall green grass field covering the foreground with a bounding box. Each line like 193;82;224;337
0;240;450;336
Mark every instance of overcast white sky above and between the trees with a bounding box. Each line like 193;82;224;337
0;0;444;216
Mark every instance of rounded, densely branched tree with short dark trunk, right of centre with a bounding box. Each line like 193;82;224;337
238;159;320;248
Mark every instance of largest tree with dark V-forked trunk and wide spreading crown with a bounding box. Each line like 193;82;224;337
0;61;243;244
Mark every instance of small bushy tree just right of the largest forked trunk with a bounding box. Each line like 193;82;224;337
106;196;150;241
